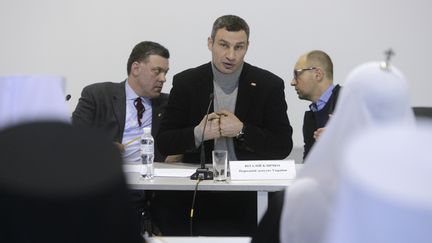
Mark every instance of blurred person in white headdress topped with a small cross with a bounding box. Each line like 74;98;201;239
280;62;415;243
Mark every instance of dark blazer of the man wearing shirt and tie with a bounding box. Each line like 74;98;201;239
72;81;168;161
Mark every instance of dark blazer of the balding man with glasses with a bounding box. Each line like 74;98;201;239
303;85;341;159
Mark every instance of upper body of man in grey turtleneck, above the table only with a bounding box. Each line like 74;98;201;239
156;15;293;163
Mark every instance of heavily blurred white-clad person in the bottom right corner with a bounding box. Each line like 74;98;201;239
325;120;432;243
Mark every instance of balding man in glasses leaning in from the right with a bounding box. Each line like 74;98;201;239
291;50;340;159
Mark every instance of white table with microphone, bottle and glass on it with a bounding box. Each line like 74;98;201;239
126;162;302;223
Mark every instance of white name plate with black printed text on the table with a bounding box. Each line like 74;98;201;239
229;160;296;180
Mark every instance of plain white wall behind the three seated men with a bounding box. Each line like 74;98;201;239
0;0;432;146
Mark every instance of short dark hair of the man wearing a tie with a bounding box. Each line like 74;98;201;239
127;41;169;75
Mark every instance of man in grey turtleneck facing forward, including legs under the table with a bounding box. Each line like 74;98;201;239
153;15;293;236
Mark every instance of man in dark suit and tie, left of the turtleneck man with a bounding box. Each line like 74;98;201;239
72;41;170;236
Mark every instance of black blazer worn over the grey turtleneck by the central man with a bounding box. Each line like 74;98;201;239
156;63;293;163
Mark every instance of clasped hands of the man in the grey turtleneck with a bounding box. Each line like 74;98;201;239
198;109;243;141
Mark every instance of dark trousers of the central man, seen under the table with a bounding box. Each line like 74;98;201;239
150;191;257;236
